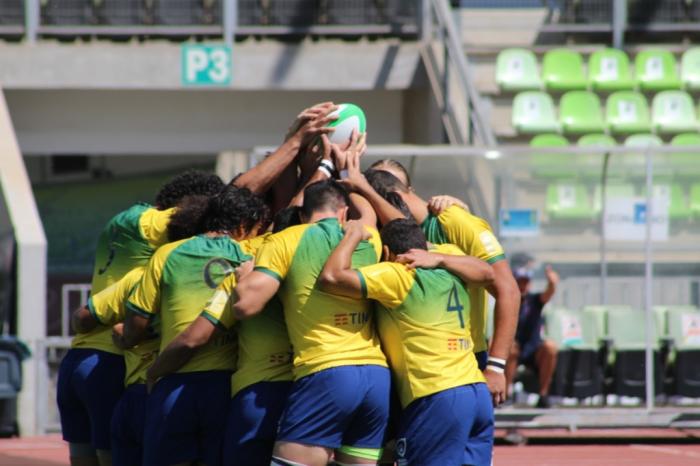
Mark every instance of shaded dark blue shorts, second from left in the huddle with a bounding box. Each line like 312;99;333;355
112;383;148;466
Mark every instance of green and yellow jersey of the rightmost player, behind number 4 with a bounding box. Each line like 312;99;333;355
421;206;506;352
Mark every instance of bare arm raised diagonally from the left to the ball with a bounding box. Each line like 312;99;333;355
234;102;336;194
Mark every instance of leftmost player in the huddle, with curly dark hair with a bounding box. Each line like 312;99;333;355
57;171;223;466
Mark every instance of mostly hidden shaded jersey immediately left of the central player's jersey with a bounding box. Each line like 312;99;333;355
202;234;294;397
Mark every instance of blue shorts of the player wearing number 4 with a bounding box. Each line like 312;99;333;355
396;383;494;466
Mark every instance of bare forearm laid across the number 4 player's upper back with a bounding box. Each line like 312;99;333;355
397;249;494;286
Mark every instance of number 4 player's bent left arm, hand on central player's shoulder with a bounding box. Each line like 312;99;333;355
318;221;369;298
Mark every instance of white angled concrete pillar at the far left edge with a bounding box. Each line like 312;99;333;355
0;90;48;435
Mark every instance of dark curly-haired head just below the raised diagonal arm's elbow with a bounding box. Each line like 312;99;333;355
203;185;269;240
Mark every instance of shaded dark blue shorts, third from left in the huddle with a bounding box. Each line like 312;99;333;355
143;371;231;466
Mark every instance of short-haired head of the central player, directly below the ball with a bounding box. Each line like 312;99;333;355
301;180;350;223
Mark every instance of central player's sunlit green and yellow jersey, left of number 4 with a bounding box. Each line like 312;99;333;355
255;218;386;379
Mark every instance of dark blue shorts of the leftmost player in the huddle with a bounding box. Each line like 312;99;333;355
56;348;124;450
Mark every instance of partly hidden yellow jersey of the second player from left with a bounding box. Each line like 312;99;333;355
87;267;160;387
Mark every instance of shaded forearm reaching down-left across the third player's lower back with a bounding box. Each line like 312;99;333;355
146;316;216;387
